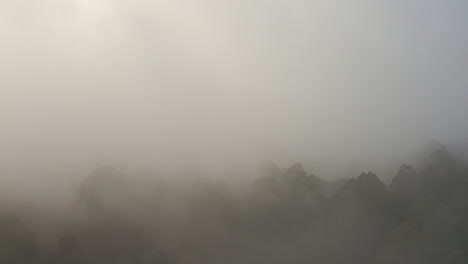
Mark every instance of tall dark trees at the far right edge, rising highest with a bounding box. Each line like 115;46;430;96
377;149;468;264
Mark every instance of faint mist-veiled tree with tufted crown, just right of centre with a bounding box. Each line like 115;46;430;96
246;163;325;236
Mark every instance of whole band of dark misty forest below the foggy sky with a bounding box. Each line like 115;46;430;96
0;148;468;264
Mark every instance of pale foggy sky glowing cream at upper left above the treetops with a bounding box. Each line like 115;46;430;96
0;0;468;195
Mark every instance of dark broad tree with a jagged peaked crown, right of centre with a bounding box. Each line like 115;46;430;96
323;172;397;263
